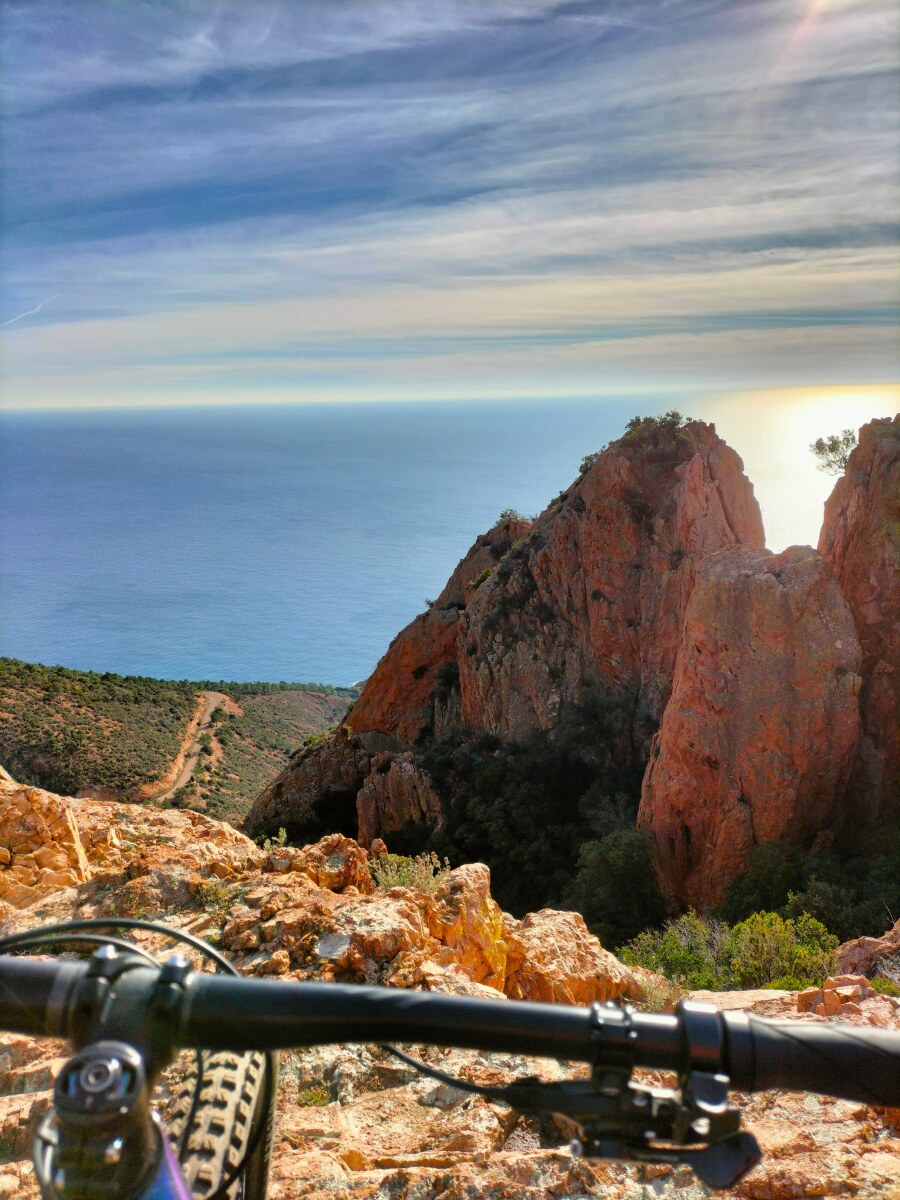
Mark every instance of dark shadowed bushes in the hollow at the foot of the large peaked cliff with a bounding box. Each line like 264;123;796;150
416;688;664;921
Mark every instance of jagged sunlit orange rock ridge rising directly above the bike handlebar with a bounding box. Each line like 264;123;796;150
0;775;647;1003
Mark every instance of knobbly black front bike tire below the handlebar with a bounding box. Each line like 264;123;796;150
168;1050;275;1200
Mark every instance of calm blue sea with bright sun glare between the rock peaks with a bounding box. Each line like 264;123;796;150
0;395;889;685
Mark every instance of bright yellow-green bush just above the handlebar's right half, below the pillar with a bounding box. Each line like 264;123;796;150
619;911;838;991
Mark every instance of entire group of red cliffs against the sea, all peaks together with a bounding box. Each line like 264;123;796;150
247;419;900;910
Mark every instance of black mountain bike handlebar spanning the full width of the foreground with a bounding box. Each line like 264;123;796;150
0;958;900;1106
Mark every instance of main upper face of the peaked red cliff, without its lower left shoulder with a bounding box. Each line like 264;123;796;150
460;421;764;738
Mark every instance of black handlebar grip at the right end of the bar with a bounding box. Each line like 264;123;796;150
722;1013;900;1108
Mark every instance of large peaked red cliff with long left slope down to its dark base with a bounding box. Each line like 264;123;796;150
246;421;763;864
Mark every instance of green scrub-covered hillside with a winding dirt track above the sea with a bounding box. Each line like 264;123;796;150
0;659;354;820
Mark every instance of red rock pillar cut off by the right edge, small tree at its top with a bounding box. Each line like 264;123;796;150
818;416;900;841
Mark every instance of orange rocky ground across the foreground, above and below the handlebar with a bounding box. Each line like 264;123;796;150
0;776;900;1200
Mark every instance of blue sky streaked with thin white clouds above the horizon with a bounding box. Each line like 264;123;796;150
0;0;900;408
